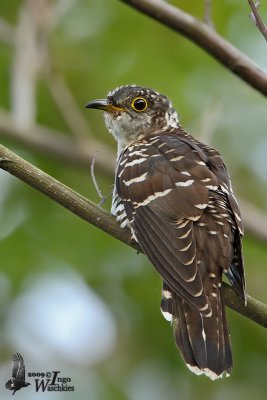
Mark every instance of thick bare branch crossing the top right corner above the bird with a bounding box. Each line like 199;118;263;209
120;0;267;96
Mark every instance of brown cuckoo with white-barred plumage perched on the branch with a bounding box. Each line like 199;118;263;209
85;85;246;380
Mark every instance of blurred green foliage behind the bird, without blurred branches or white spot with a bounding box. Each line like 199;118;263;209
0;0;267;400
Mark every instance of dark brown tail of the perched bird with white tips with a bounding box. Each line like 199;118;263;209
161;284;232;380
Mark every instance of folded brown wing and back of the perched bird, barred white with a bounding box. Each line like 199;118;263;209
116;131;246;315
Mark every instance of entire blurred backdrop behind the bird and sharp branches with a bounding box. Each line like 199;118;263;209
0;0;267;400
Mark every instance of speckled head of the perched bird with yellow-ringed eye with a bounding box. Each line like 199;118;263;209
85;85;178;148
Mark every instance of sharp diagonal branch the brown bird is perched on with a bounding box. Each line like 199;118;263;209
0;145;267;328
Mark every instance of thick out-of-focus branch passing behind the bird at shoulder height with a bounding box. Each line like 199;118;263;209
0;109;267;242
